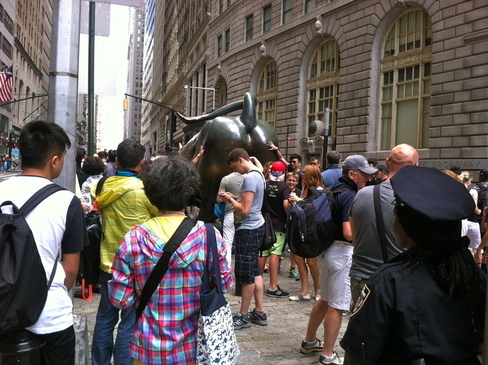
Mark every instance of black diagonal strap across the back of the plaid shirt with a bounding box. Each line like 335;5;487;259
136;217;196;322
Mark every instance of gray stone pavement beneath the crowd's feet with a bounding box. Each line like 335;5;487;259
74;255;349;365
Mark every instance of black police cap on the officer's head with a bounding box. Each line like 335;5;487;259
391;165;475;221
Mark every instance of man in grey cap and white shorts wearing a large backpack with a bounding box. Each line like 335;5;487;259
300;155;377;364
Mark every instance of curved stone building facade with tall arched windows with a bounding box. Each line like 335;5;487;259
148;0;488;170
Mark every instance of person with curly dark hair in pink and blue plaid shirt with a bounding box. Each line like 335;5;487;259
108;155;232;365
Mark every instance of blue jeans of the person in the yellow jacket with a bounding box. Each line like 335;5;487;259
92;271;136;365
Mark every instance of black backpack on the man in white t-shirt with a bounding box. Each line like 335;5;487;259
0;184;65;335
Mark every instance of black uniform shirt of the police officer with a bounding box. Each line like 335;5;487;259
341;260;486;365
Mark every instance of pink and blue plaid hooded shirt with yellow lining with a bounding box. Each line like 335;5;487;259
108;217;233;364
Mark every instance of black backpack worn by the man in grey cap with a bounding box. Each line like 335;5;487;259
286;186;351;258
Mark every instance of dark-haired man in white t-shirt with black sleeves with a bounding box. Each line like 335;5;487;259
0;121;87;365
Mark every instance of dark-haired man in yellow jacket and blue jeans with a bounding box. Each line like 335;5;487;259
92;139;158;365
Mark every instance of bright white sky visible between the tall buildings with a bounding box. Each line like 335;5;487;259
78;1;130;150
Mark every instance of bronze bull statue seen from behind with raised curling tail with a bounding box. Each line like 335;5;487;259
178;92;278;222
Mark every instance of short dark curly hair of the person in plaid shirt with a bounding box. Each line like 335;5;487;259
141;154;200;211
